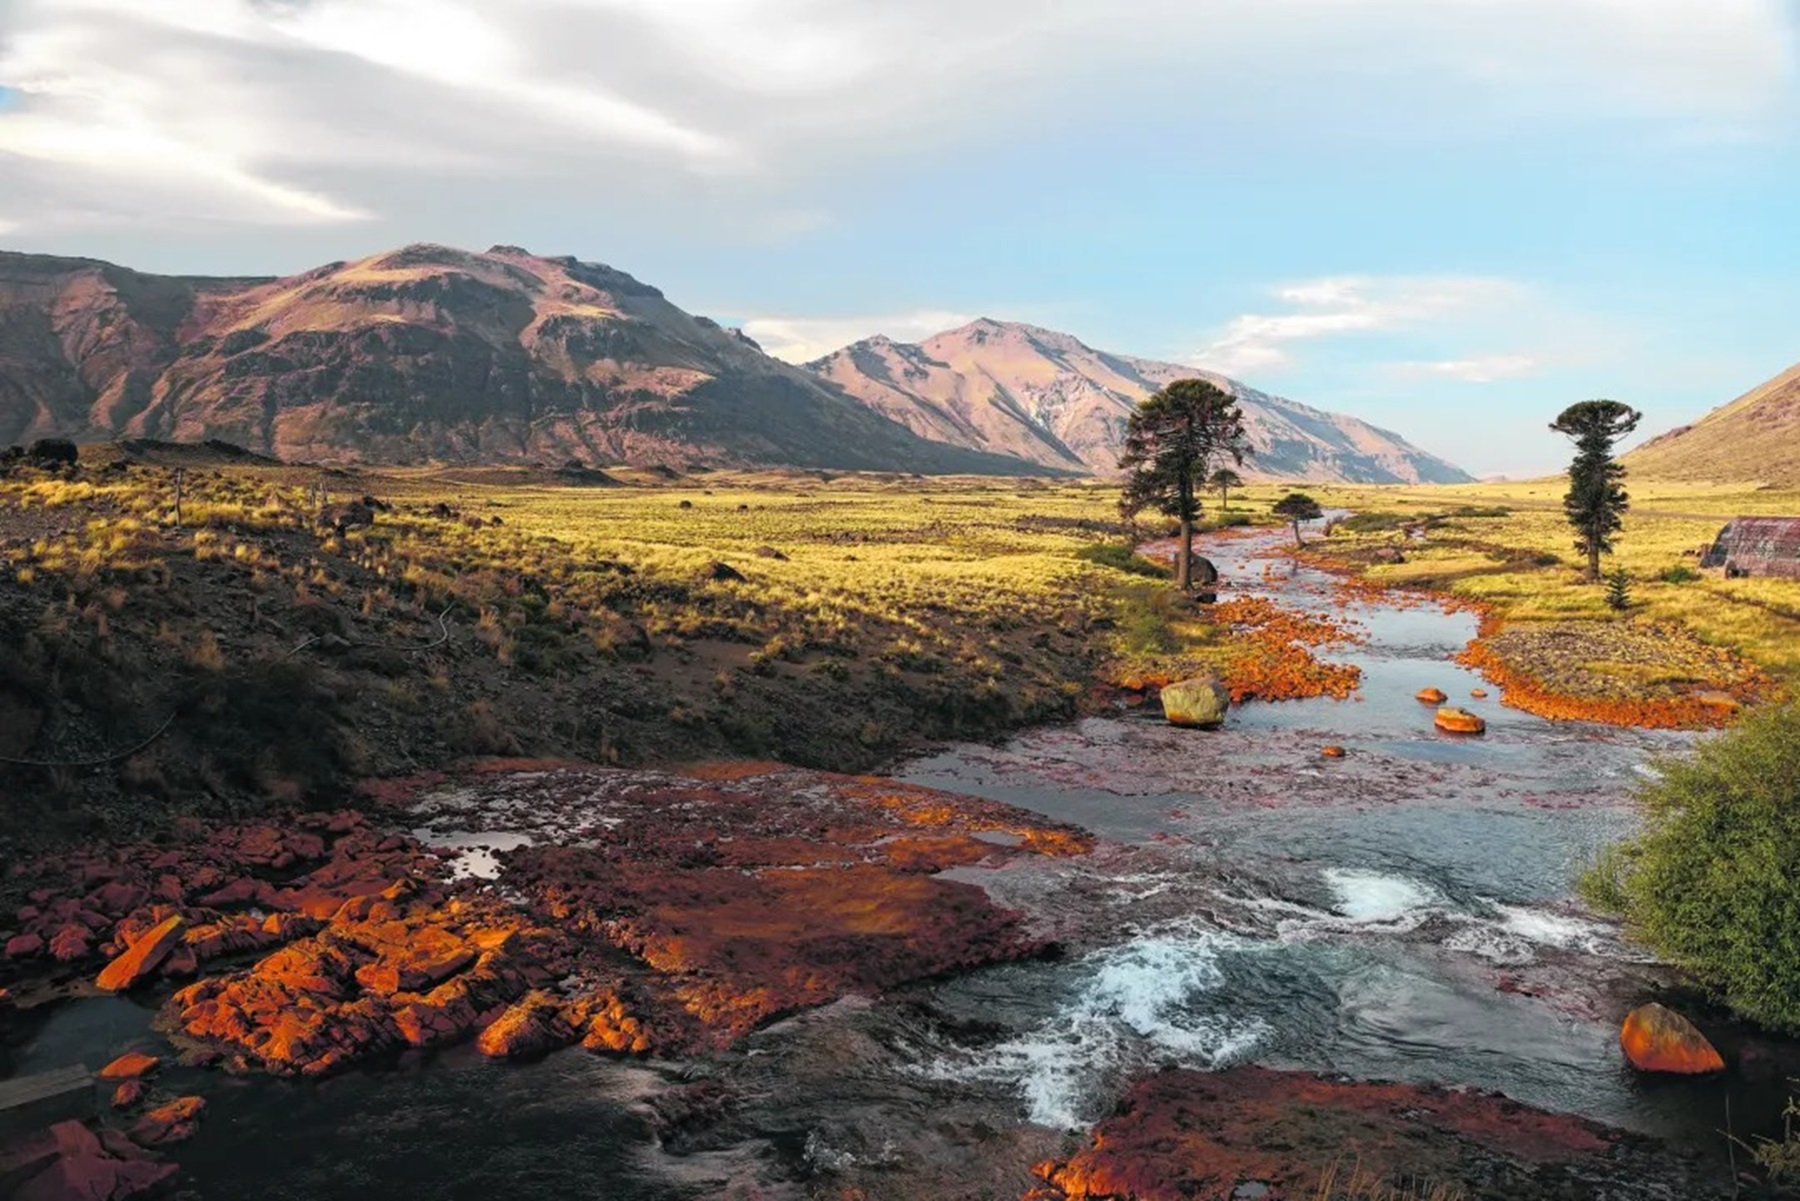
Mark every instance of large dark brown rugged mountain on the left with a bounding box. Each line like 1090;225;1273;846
0;245;1042;474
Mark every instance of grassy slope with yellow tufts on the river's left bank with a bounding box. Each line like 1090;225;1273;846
0;461;1130;857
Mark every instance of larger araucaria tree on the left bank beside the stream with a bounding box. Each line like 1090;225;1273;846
1120;380;1249;591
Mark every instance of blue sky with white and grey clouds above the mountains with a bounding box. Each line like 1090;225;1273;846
0;0;1800;475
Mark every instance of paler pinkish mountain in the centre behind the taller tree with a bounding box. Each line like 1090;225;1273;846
806;319;1471;484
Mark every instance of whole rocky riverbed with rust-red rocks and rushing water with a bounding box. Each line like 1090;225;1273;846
0;537;1795;1201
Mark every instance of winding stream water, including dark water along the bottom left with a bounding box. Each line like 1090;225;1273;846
9;535;1784;1199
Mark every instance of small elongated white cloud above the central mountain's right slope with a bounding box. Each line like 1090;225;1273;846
1192;275;1525;375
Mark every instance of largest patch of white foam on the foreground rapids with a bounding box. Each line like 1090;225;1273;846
923;927;1269;1129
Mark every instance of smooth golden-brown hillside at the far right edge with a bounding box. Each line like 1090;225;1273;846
1624;364;1800;486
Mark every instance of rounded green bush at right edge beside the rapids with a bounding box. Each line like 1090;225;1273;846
1580;706;1800;1032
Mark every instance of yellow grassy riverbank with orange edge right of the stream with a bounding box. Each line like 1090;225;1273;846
1267;479;1800;729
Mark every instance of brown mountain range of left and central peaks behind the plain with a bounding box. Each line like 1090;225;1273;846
0;245;1469;483
